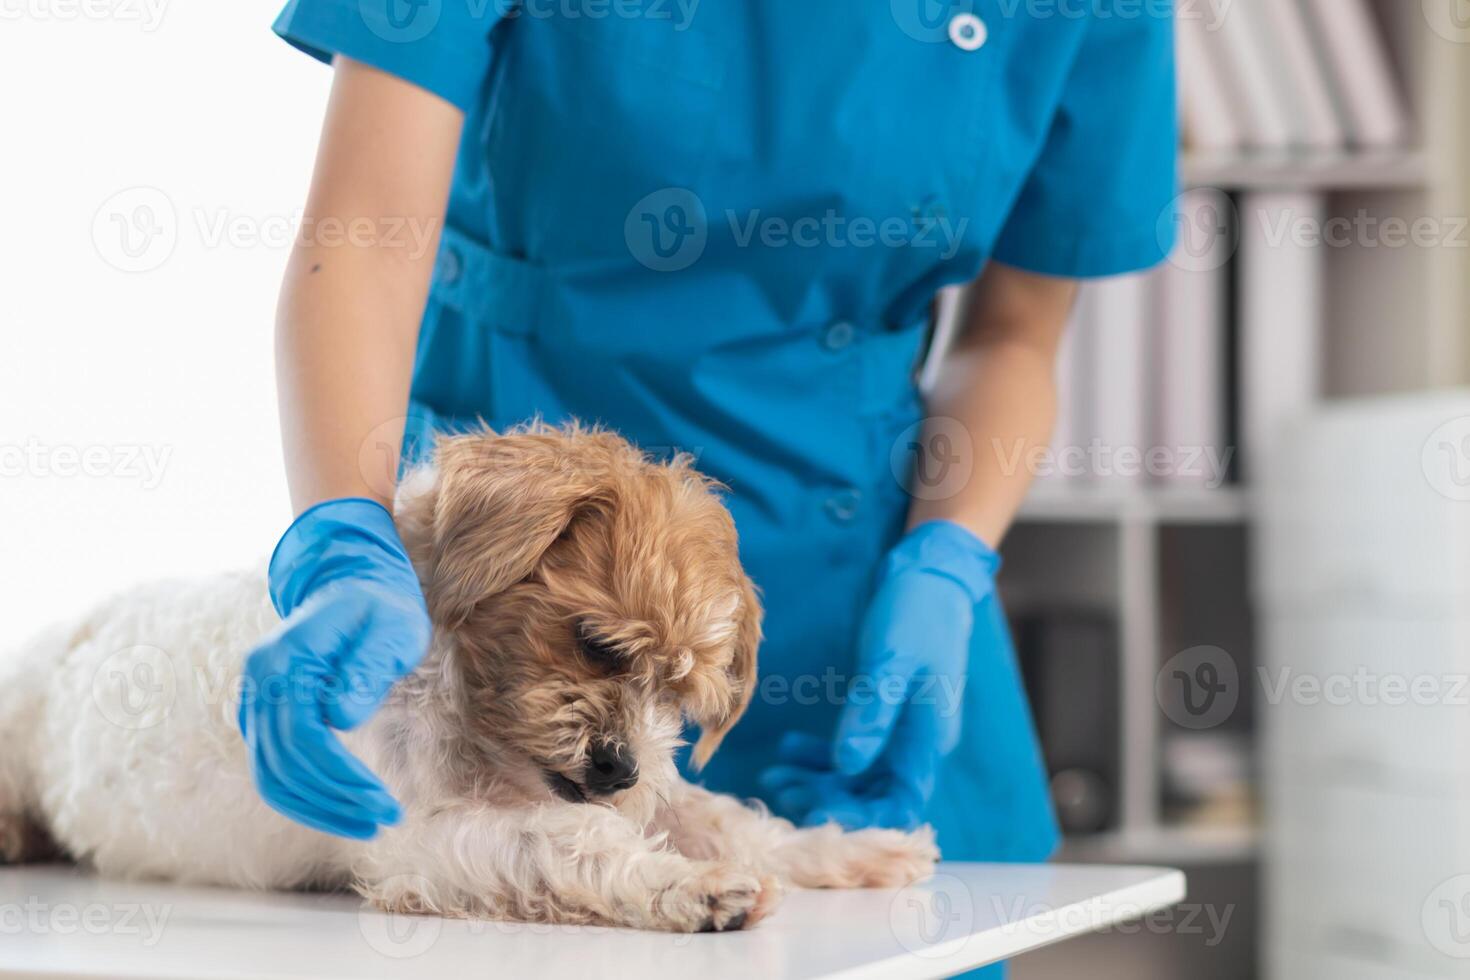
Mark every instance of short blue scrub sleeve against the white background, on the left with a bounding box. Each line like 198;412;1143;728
273;0;504;112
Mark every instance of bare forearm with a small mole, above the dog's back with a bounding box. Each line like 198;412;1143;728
276;57;463;513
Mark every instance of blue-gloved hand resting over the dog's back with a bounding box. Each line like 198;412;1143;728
240;498;431;839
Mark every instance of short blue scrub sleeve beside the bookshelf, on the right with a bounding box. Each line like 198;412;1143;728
992;0;1179;278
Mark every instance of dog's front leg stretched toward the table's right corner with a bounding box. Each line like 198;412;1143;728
657;782;939;887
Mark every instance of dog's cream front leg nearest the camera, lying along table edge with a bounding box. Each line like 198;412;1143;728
353;802;781;932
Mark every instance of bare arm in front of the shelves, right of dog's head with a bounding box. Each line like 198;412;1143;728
908;263;1076;547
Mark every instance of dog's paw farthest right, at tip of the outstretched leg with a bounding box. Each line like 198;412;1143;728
788;824;939;887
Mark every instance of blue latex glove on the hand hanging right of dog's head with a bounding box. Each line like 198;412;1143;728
760;520;999;829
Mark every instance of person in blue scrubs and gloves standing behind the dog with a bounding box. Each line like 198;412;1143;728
241;0;1176;963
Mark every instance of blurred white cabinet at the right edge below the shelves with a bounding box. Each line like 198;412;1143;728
1255;392;1470;980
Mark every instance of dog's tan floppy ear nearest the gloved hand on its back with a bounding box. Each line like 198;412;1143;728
425;432;609;629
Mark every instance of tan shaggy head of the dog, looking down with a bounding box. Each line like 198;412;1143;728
398;426;761;810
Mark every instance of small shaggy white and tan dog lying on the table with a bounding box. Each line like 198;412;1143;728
0;426;938;932
